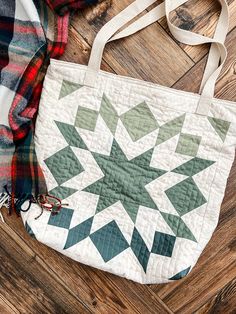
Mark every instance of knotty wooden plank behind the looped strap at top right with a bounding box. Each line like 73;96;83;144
159;0;236;62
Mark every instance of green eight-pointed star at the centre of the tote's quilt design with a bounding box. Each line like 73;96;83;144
84;140;165;222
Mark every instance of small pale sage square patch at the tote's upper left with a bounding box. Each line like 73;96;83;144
75;107;98;131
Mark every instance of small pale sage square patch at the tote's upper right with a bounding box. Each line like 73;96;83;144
176;133;201;157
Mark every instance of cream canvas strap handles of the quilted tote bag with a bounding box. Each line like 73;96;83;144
84;0;229;115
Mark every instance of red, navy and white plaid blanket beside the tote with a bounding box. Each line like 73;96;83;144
0;0;96;211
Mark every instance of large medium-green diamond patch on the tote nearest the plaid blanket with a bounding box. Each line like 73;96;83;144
45;146;84;185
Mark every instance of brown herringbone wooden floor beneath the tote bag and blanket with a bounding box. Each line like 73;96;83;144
0;0;236;314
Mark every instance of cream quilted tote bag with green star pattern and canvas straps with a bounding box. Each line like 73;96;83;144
22;0;236;283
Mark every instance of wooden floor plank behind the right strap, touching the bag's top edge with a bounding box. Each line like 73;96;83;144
173;28;236;101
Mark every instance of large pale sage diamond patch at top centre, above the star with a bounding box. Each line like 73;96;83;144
120;102;158;142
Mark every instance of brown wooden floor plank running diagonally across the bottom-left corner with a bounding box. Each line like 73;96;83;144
0;224;92;313
